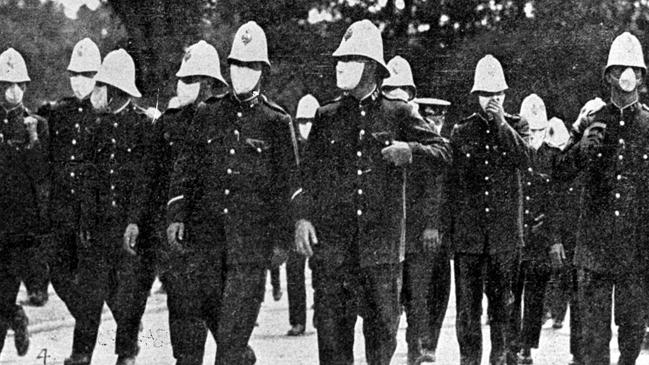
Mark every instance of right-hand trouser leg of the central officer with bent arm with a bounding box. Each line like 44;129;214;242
359;265;402;365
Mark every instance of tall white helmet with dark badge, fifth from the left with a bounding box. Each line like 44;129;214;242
228;21;270;67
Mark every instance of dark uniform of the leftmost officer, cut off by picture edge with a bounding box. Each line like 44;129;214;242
0;106;49;351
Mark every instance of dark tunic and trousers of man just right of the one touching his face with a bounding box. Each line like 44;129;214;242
511;143;563;349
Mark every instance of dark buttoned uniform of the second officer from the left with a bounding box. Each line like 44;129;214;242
38;98;96;308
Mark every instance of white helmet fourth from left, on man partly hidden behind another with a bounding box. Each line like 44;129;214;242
176;40;228;85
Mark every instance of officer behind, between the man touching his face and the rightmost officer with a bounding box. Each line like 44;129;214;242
510;94;566;364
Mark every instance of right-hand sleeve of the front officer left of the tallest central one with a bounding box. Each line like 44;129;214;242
270;115;298;249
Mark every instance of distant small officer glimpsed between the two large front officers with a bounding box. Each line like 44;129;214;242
286;94;320;336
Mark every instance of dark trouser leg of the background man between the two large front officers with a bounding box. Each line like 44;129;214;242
286;251;306;326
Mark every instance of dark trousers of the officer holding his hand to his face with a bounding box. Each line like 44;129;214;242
454;253;518;365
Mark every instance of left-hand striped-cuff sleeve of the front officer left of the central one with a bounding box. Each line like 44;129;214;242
167;105;208;223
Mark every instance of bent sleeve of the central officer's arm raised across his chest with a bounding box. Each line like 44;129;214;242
400;109;452;170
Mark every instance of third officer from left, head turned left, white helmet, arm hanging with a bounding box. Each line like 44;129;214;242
65;49;154;365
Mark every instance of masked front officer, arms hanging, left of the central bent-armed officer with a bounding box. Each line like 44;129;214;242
167;22;297;365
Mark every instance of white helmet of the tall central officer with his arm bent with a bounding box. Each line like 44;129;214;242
333;19;390;78
